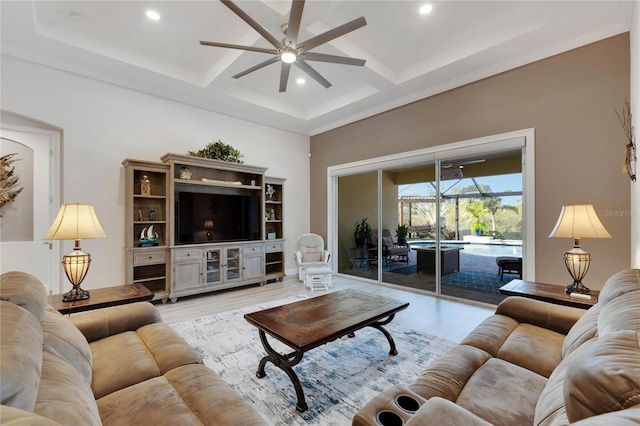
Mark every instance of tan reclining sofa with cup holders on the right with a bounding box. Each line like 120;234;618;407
353;269;640;426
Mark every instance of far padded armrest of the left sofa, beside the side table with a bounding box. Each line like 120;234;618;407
69;302;162;343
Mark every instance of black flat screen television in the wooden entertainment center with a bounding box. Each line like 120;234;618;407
175;192;261;244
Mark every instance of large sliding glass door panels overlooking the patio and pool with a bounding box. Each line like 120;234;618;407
335;131;526;303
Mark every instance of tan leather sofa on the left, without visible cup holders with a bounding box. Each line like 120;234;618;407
0;272;266;426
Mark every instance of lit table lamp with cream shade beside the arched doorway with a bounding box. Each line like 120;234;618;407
43;204;106;302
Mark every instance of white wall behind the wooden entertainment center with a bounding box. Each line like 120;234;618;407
0;55;310;289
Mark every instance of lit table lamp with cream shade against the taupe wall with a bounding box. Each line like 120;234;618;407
549;204;611;294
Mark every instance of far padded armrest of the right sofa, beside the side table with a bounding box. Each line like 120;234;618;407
496;296;586;334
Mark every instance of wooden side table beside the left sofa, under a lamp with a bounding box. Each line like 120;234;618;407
49;283;153;315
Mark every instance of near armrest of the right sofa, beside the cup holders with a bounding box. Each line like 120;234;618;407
407;397;491;426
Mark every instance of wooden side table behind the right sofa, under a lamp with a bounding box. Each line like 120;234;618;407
500;280;600;309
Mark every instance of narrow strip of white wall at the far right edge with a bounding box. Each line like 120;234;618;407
630;1;640;268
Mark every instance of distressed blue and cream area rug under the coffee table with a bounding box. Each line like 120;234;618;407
172;295;455;426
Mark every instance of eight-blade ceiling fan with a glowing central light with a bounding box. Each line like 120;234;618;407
200;0;367;92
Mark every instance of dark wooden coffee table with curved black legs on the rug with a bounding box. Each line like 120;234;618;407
244;290;409;412
